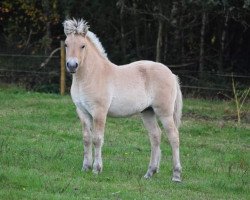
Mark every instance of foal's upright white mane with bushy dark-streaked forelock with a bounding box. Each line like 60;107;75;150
63;18;107;58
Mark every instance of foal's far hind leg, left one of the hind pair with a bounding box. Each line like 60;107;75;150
142;108;161;178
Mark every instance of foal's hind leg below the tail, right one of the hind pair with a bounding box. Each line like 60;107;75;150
159;115;181;182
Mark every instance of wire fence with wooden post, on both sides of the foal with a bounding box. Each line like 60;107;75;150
0;42;250;97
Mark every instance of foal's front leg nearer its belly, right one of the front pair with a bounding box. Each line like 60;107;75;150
93;113;106;174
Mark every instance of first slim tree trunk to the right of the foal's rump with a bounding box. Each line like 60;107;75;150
199;10;207;79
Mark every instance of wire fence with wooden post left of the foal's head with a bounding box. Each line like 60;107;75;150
0;42;66;95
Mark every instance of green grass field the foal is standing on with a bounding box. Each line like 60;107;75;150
0;88;250;200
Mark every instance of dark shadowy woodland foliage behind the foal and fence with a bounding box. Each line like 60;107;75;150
0;0;250;94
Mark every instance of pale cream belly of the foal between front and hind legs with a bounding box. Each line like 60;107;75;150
108;92;150;117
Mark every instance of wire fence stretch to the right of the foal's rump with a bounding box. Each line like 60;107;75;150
173;69;250;97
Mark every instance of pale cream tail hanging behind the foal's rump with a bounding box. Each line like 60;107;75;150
174;76;183;128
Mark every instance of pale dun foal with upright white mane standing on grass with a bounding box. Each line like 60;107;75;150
63;19;182;182
